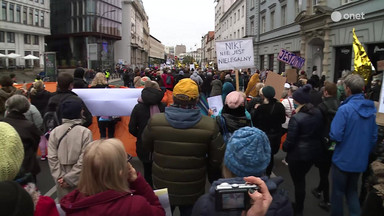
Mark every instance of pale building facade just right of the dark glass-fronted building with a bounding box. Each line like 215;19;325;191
115;0;150;68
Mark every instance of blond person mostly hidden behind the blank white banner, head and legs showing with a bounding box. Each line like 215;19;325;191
91;72;116;138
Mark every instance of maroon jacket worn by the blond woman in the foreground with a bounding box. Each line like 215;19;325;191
60;173;165;216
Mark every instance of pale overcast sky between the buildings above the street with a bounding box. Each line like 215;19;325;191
143;0;216;52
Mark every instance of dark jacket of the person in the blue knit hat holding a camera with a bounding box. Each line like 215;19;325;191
192;177;293;216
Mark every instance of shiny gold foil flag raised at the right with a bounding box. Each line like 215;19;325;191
352;28;372;84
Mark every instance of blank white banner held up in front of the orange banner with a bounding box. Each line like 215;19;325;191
72;88;143;116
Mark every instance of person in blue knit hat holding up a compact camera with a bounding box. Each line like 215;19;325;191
192;127;293;216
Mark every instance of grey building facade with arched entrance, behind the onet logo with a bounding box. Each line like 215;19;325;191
246;0;384;81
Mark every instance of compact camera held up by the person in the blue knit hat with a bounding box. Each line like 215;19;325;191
215;182;259;211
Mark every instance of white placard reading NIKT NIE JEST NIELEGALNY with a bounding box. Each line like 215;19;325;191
216;38;255;70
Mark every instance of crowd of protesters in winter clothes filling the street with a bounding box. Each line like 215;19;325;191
0;64;384;216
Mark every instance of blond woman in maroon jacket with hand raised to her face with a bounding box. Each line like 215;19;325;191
60;139;165;216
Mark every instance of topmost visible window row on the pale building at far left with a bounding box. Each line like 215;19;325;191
1;0;45;27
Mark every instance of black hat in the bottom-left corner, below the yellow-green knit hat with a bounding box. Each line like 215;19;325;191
0;181;34;216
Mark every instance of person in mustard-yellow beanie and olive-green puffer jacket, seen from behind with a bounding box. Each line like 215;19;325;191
142;78;225;216
